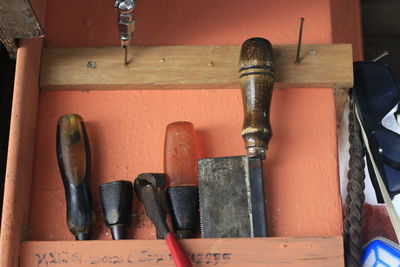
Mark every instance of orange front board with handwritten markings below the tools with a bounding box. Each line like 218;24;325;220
20;236;344;267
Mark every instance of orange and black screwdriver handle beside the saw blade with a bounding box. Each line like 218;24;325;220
164;121;199;238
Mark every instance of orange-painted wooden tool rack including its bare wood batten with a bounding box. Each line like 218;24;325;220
0;0;353;267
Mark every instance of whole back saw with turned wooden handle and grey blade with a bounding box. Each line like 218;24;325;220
198;38;275;238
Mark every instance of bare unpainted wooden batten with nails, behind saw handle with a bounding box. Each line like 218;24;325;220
40;44;353;90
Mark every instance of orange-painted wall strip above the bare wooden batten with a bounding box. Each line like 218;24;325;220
46;0;337;47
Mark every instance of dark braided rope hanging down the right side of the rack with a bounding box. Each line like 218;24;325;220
344;101;365;267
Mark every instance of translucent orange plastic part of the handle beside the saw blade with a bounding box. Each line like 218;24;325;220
164;121;198;186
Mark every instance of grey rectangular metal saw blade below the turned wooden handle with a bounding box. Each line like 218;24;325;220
198;156;266;238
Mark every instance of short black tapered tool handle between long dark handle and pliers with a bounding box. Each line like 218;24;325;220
99;180;132;240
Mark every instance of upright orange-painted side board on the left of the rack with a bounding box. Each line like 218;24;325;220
0;40;45;267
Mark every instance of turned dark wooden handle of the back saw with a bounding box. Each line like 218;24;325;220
239;38;275;159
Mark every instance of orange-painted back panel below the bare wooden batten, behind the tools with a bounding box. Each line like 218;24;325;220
29;89;341;240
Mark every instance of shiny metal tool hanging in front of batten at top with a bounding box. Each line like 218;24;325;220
114;0;135;65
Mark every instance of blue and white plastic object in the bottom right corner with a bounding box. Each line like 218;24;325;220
361;237;400;267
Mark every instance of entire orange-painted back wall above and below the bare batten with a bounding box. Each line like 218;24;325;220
29;0;342;240
